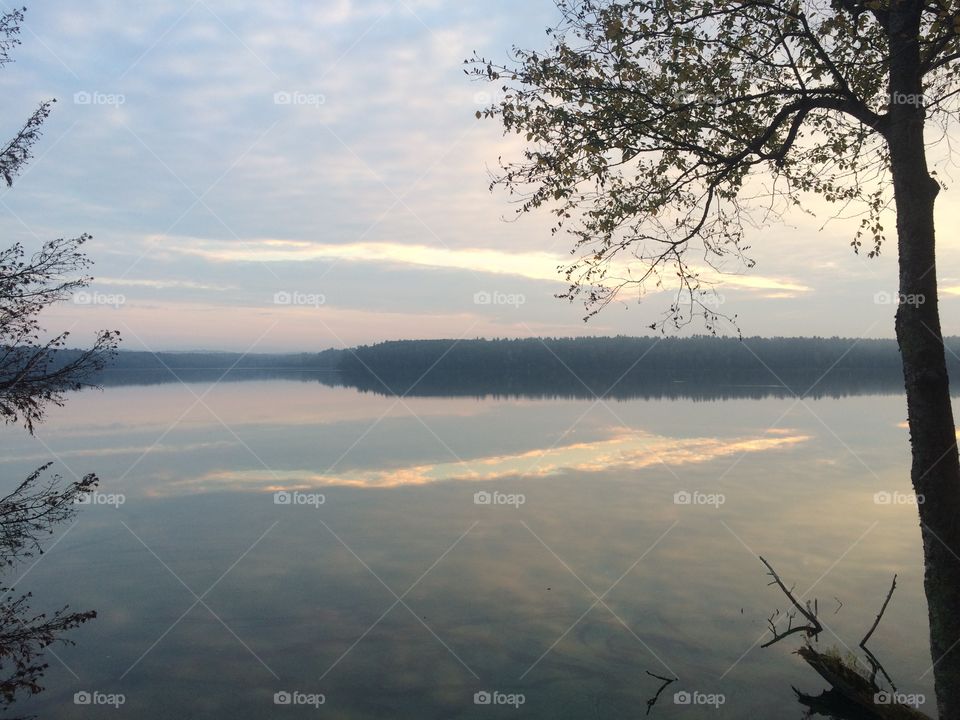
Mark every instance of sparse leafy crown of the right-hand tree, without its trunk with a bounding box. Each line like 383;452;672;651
467;0;960;330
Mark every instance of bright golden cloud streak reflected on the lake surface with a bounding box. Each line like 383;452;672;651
156;428;811;496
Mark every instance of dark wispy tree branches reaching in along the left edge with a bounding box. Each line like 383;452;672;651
0;9;120;716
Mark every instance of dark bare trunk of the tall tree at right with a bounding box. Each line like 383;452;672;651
886;0;960;720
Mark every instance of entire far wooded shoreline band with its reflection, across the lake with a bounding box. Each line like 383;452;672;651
54;336;960;400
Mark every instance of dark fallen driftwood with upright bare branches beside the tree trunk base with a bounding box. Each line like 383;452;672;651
760;557;930;720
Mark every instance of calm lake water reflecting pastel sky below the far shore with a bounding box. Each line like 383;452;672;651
0;380;935;719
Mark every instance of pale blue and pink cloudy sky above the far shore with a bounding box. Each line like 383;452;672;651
0;0;960;352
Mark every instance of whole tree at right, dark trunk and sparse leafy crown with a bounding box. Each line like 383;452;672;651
467;0;960;718
